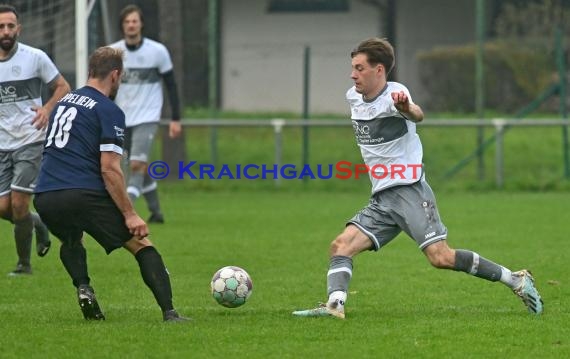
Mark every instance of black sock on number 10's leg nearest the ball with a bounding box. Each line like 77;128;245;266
135;246;174;312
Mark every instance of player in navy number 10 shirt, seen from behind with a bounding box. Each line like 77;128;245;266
34;47;186;321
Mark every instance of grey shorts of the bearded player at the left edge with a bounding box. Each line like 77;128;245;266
0;142;44;196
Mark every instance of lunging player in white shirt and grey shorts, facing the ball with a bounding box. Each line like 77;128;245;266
293;38;543;318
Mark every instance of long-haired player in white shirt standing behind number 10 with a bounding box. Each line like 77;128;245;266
110;5;182;223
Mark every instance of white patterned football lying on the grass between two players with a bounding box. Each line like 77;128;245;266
210;266;253;308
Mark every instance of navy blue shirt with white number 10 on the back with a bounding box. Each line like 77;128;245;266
35;86;125;193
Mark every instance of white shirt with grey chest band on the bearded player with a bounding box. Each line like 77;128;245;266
0;42;59;151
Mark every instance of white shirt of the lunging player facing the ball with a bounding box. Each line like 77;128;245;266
346;82;423;193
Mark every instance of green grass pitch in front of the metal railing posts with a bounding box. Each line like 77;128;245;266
0;187;570;358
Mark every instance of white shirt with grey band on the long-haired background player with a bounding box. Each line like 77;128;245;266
109;37;172;127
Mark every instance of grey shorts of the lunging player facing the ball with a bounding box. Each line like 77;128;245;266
347;179;447;250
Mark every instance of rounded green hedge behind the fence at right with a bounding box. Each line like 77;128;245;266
418;41;556;113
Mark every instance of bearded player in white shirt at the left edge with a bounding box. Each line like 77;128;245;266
0;4;70;275
